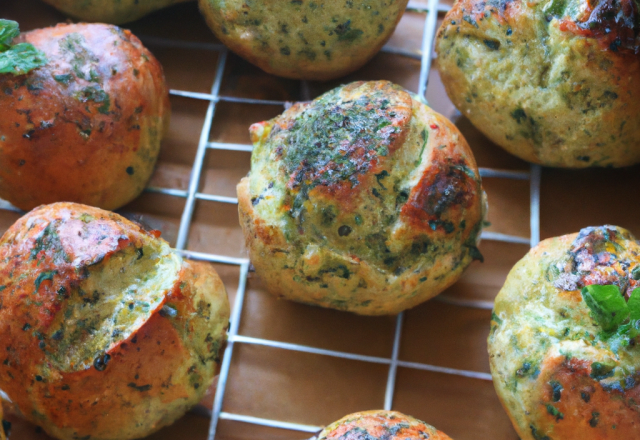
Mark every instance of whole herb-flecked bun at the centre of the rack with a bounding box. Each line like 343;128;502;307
238;81;484;315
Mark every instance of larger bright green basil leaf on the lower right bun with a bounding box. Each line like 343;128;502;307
582;284;629;331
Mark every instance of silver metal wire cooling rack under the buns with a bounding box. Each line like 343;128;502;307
0;0;541;440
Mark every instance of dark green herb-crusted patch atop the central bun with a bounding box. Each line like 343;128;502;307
267;81;411;215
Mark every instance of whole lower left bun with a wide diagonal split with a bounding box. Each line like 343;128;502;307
0;203;229;440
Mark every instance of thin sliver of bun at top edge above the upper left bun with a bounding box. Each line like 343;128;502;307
44;0;190;24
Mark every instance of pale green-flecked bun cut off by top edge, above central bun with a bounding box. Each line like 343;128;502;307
199;0;408;80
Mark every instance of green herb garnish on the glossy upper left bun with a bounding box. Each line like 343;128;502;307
0;19;47;75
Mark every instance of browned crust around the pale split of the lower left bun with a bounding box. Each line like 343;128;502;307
0;203;229;439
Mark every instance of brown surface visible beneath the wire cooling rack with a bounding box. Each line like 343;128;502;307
0;0;640;440
